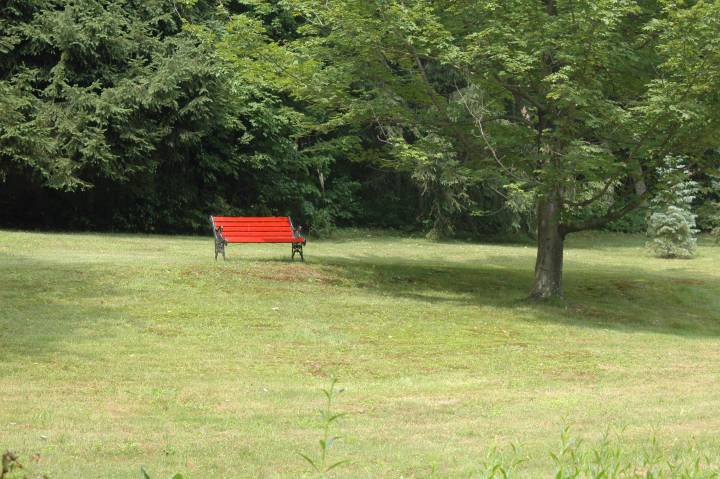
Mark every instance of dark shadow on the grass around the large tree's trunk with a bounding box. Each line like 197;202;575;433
317;255;720;337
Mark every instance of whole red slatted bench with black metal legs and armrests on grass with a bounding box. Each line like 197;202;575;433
210;216;307;261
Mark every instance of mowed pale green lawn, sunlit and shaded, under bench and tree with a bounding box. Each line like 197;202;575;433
0;231;720;478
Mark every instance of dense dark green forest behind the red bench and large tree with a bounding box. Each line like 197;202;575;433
0;0;717;240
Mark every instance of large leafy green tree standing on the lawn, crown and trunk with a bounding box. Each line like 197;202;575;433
224;0;720;298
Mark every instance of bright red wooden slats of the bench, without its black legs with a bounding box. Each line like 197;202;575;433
210;216;304;243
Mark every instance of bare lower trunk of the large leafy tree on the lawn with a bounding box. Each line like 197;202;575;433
530;193;565;299
